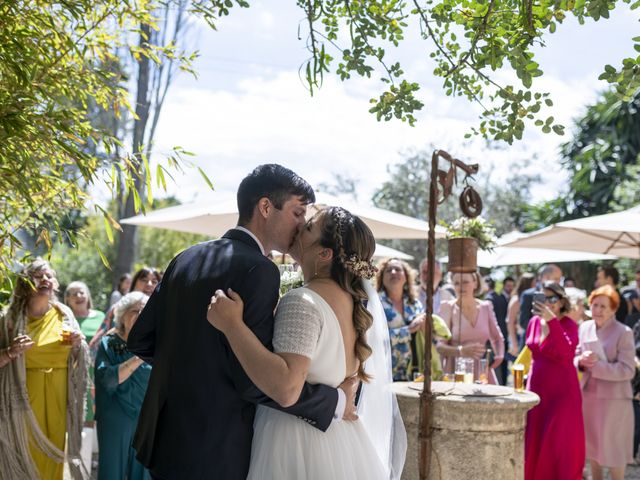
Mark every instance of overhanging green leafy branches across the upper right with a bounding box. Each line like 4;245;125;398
298;0;640;143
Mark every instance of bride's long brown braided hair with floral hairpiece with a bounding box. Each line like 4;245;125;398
320;207;376;381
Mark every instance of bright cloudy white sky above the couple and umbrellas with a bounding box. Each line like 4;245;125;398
138;0;639;208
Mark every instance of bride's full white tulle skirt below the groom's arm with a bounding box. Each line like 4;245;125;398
247;406;389;480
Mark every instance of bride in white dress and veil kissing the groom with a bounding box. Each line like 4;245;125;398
207;207;406;480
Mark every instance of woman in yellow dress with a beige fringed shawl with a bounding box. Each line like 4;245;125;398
0;259;89;480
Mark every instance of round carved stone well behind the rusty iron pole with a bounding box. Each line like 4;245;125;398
393;382;540;480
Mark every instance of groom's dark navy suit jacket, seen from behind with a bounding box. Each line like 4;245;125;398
127;229;338;480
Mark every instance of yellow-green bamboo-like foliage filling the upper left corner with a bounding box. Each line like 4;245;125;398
0;0;221;284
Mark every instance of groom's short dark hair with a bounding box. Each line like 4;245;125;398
238;163;316;225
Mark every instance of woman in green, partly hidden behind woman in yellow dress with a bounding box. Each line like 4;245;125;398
64;282;104;427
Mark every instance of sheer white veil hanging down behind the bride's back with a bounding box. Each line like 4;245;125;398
358;278;407;480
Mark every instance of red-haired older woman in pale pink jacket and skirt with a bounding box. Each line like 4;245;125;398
575;285;635;480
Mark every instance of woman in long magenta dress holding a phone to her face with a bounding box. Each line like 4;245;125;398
524;282;585;480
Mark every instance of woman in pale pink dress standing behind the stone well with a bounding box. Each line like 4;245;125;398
437;272;504;384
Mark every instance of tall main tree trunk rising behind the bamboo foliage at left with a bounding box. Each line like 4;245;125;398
112;24;151;287
